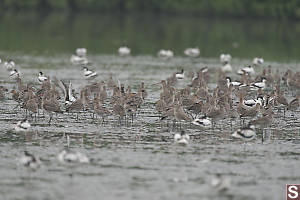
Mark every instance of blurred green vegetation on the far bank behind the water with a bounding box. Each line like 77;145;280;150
0;0;300;19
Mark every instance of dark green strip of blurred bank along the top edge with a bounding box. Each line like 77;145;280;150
0;0;300;21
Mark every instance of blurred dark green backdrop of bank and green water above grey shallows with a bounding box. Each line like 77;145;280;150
0;0;300;62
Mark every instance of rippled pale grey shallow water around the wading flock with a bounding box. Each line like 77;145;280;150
0;50;300;199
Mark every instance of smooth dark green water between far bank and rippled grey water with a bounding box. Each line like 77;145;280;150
0;13;300;62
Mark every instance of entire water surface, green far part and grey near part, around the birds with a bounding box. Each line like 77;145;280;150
0;12;300;199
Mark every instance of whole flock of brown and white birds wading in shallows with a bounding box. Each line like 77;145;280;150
0;47;300;168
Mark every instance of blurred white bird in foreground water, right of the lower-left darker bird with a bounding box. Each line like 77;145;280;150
57;149;90;163
